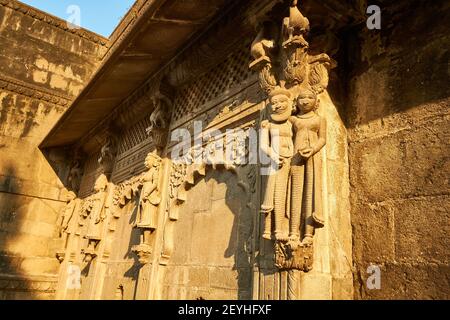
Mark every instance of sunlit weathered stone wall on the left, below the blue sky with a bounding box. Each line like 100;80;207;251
0;0;108;299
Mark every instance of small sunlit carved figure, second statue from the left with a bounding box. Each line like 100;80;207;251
86;174;108;240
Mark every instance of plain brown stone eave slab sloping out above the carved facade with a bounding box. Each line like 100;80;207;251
39;0;236;149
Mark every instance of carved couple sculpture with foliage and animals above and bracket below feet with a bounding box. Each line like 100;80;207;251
249;0;334;271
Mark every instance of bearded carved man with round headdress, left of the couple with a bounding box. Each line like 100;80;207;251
261;88;294;241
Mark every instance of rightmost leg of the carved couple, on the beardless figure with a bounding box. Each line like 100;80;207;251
302;158;314;245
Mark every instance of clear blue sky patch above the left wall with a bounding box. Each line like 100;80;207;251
20;0;135;37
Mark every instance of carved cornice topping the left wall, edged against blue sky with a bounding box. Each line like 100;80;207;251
0;0;109;46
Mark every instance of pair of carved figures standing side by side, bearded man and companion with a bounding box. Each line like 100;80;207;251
261;89;326;245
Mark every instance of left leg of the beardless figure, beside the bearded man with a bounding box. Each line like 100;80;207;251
289;165;305;242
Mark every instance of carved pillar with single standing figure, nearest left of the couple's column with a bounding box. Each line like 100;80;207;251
132;81;172;299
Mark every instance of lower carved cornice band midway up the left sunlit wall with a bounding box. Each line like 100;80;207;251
0;73;72;107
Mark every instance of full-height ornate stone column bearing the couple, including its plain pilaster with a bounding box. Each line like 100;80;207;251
250;0;351;299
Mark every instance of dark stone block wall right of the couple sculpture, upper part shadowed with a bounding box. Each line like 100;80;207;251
347;1;450;299
